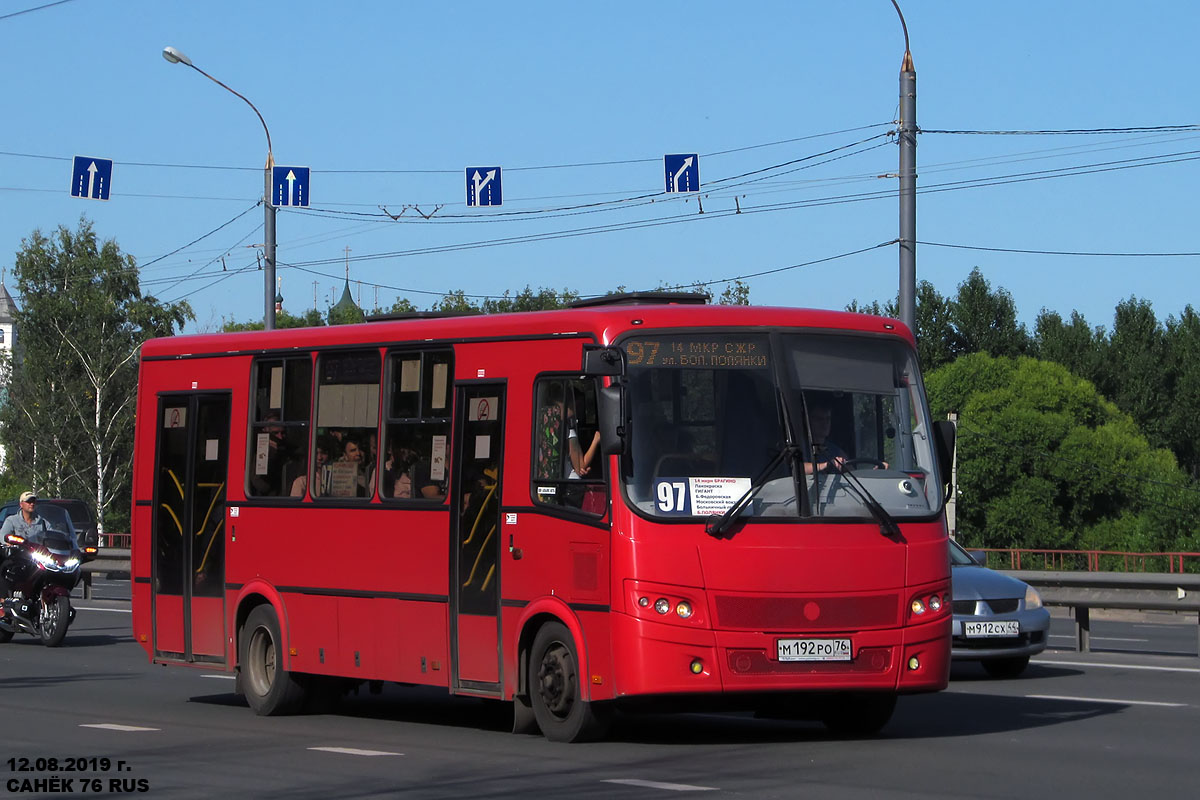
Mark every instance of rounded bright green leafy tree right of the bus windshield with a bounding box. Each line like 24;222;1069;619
925;353;1200;561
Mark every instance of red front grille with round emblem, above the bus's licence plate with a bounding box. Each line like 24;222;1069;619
715;595;900;632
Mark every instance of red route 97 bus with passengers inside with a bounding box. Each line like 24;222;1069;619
132;293;953;741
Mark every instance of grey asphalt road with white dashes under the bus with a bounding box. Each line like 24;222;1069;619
0;593;1200;800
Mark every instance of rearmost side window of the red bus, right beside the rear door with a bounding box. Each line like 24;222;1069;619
246;355;312;498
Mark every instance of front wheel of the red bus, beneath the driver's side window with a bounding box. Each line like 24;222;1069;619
529;622;612;741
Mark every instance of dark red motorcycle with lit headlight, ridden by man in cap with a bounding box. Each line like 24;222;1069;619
0;530;96;648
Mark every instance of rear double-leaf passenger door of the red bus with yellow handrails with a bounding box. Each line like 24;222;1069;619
151;395;230;663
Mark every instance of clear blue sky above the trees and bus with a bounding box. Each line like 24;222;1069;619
0;0;1200;330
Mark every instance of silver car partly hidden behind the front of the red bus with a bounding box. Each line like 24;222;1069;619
950;540;1050;678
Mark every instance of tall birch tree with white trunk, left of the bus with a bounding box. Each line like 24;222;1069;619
0;219;192;533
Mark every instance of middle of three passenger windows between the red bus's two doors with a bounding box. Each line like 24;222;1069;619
310;350;379;498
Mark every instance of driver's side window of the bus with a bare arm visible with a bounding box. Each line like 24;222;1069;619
530;378;607;515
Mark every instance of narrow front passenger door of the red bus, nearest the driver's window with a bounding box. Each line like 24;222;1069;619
450;384;504;693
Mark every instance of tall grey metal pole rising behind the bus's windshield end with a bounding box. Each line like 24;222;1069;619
892;0;917;336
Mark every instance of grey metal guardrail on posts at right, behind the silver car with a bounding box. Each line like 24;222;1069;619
1004;570;1200;655
